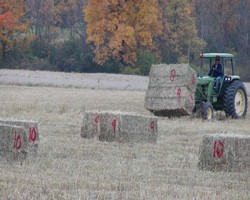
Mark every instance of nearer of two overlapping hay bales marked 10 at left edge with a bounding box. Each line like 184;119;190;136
0;124;28;161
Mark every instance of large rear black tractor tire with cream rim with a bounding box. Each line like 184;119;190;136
223;80;247;119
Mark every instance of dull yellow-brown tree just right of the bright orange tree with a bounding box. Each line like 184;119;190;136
163;0;205;63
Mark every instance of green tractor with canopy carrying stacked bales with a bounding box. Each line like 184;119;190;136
193;53;247;120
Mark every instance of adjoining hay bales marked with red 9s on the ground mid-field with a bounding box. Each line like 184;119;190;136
81;111;157;143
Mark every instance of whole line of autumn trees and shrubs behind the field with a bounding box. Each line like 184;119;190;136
0;0;250;78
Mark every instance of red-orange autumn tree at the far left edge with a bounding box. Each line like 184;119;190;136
0;0;29;60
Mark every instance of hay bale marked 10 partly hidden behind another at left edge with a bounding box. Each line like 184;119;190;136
0;119;39;157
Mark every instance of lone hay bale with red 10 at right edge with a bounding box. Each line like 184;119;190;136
198;134;250;172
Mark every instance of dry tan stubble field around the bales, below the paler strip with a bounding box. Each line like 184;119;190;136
0;70;250;200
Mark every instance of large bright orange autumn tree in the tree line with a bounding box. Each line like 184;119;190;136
84;0;162;64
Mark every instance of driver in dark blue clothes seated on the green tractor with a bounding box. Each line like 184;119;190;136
208;57;223;92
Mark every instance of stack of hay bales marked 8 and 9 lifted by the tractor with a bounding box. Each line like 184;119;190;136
145;64;197;117
